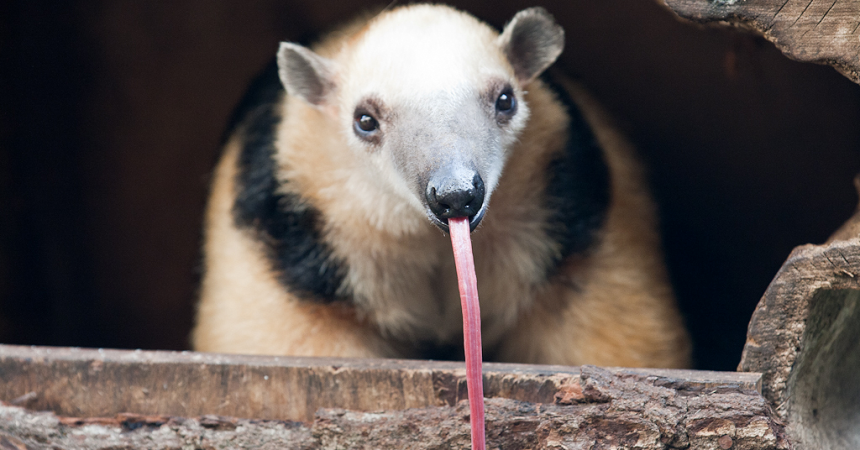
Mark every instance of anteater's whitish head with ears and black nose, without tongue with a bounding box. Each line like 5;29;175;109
277;5;564;231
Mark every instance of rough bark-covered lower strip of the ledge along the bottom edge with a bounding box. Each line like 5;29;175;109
0;366;791;450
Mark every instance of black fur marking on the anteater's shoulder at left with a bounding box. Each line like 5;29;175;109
231;59;346;303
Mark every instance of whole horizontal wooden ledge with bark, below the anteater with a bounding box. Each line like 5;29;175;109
0;352;790;449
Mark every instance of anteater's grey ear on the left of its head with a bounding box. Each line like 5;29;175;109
278;42;335;106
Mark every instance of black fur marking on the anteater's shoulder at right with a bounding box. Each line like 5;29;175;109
541;73;610;272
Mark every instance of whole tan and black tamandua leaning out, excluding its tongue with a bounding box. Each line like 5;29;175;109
192;5;690;367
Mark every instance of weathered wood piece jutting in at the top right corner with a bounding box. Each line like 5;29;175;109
663;0;860;83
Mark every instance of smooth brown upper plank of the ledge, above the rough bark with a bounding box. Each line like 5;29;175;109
0;345;760;421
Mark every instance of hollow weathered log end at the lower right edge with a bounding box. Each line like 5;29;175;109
739;179;860;450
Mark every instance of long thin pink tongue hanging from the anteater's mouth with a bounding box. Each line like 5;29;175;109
448;217;486;450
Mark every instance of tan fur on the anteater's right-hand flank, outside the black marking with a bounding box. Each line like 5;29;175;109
499;83;690;368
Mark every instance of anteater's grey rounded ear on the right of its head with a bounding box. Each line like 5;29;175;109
498;7;564;84
